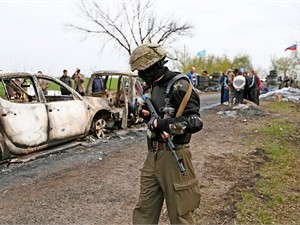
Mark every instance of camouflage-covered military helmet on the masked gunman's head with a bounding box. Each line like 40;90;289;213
129;43;167;71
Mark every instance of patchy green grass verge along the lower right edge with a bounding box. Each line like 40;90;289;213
237;102;300;224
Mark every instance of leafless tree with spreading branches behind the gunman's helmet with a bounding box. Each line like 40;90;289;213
67;0;193;55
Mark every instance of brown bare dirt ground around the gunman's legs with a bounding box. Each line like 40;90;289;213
0;102;268;224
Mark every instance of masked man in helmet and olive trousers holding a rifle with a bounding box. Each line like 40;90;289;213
129;43;203;224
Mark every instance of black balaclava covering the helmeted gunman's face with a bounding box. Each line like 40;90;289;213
138;60;167;86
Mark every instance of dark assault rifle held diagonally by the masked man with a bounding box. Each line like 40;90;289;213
142;95;186;176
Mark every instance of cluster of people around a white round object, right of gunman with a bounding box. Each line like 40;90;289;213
220;69;261;105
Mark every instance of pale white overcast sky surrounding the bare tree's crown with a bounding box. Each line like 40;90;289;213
0;0;300;76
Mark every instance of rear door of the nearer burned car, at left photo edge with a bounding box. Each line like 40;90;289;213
0;77;48;148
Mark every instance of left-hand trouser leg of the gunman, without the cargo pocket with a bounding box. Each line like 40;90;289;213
133;152;164;224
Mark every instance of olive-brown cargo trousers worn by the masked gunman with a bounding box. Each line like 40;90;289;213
133;148;201;224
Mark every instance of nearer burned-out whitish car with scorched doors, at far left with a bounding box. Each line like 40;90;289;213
0;72;114;159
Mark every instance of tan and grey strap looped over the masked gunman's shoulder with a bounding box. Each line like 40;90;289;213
165;74;193;117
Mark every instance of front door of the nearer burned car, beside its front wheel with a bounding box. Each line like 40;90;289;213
45;81;89;141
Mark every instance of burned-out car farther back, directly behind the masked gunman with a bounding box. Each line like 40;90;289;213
85;71;143;129
